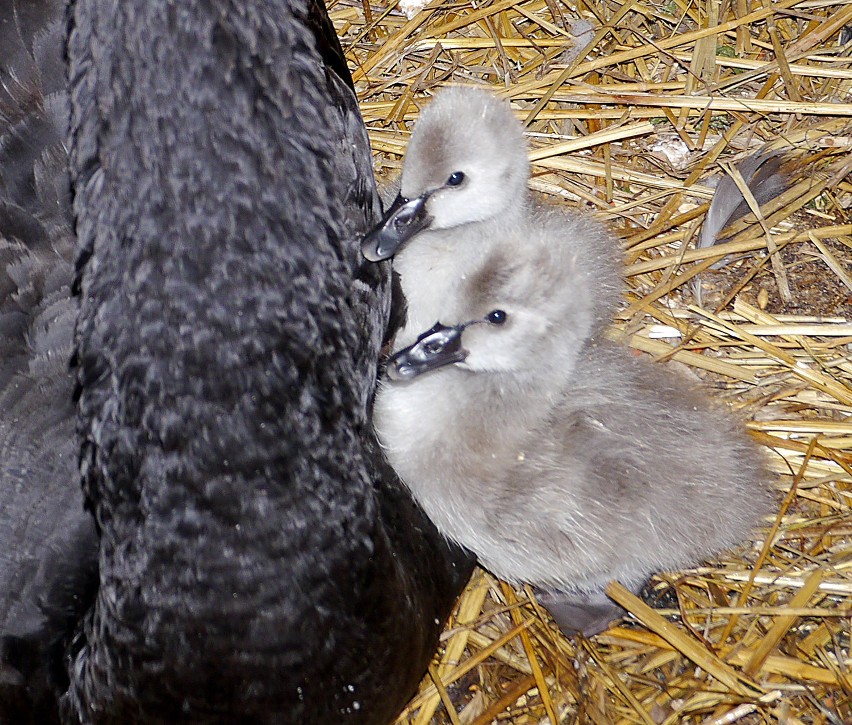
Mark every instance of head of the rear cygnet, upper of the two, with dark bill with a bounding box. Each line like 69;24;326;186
361;87;530;262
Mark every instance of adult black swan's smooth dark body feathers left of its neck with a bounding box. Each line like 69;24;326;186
0;1;97;724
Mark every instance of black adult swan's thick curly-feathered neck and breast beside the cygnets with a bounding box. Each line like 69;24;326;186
0;0;471;723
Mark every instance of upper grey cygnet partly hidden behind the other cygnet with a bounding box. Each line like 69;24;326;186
361;87;622;348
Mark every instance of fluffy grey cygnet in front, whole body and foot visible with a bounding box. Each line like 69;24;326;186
374;233;772;635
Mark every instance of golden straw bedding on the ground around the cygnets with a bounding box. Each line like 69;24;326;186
330;0;852;725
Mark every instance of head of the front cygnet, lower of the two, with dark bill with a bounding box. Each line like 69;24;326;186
387;240;595;388
